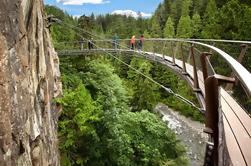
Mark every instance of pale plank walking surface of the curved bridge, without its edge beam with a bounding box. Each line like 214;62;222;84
148;52;251;166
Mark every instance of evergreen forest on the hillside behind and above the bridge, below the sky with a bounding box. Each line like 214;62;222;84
46;0;251;42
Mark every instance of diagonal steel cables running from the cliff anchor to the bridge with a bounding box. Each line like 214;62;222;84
56;22;203;112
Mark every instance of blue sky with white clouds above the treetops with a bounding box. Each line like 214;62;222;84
44;0;163;17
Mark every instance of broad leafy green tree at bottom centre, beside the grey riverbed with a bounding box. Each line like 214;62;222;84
100;111;187;166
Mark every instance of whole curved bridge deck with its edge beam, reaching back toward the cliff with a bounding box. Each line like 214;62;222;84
59;49;251;166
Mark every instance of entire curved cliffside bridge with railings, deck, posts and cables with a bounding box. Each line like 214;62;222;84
51;19;251;166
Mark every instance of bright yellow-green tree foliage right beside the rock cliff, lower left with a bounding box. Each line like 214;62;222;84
57;84;100;165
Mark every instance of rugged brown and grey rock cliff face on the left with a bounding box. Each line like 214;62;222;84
0;0;61;166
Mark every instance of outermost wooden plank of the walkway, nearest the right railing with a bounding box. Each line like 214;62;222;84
221;89;251;136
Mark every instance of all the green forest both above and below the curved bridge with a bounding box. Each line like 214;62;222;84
46;0;251;166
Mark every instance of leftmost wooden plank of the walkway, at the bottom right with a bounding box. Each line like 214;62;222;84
223;116;246;166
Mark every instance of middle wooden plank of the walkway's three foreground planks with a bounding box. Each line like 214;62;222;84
221;96;251;165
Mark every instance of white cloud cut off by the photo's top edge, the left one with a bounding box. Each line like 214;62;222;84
57;0;110;5
